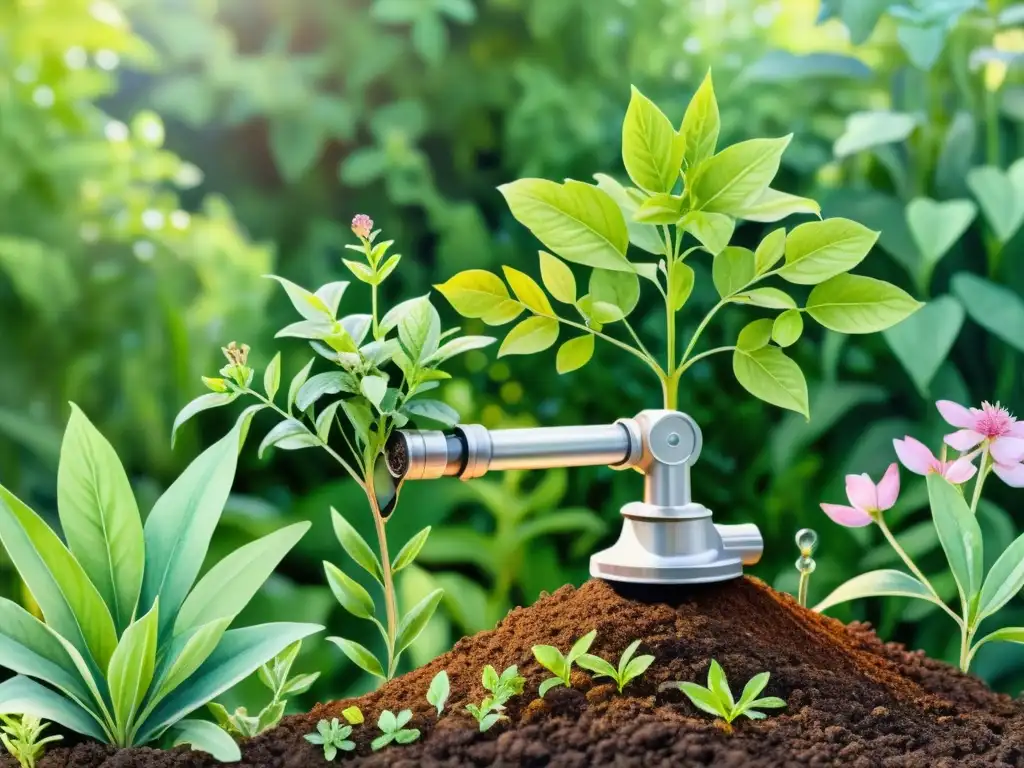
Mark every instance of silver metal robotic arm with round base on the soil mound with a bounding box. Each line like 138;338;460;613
386;411;764;584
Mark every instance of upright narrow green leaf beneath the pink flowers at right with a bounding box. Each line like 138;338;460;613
928;473;984;606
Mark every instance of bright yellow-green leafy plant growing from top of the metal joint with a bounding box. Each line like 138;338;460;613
436;74;921;416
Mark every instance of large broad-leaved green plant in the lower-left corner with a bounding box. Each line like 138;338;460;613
0;406;323;760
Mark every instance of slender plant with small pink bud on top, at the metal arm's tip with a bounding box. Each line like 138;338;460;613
174;214;495;680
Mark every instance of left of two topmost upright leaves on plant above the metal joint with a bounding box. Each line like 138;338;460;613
623;86;686;193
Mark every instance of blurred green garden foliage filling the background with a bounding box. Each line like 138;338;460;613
6;0;1024;720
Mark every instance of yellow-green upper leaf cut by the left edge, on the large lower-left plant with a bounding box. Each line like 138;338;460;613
0;487;117;669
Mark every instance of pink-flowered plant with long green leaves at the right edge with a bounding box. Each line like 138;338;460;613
815;400;1024;672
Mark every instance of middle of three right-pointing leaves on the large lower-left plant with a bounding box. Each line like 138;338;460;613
174;522;309;635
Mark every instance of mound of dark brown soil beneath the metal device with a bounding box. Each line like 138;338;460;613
12;579;1024;768
